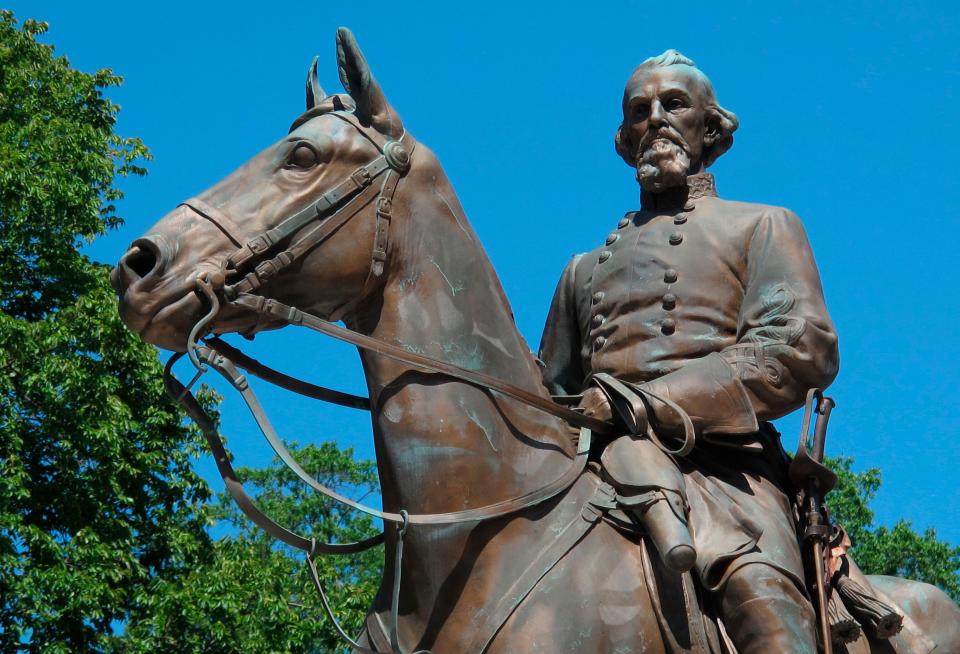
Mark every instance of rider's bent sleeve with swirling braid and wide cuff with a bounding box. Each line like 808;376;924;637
643;209;840;440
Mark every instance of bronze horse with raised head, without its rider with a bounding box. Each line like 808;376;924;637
112;28;960;654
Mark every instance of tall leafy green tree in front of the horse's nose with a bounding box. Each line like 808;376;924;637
0;11;209;652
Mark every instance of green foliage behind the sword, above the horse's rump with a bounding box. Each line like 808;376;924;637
827;457;960;601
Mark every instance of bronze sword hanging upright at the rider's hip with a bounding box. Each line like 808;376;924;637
790;388;837;654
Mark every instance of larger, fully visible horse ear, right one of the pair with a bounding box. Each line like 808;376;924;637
337;27;403;138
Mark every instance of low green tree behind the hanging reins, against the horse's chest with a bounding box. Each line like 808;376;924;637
123;443;383;654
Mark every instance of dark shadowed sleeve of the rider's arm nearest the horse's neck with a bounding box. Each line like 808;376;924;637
539;255;584;395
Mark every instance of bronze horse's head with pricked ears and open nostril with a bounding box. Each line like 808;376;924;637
111;29;413;351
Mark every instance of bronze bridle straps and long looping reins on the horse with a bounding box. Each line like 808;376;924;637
164;111;693;654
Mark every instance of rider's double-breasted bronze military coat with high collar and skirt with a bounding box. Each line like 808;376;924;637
540;174;839;588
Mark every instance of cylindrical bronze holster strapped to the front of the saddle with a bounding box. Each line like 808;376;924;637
600;436;697;572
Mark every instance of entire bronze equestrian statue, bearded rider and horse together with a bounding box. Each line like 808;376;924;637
112;29;960;654
